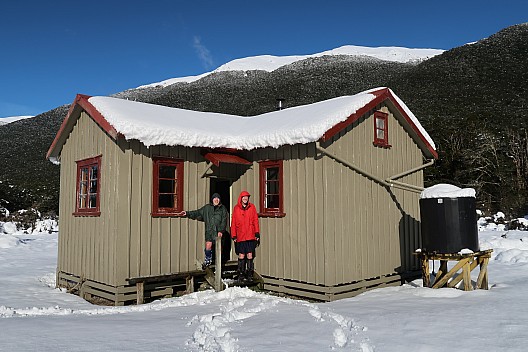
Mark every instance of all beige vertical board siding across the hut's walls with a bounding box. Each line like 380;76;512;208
57;98;423;286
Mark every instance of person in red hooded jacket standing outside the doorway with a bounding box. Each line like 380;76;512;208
231;191;260;281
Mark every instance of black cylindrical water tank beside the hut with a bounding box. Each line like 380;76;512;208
420;197;479;253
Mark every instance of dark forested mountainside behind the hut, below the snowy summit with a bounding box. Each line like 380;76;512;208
0;24;528;214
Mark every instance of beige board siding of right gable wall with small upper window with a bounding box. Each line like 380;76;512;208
325;106;423;285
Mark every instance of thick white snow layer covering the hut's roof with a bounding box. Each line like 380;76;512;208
48;88;436;163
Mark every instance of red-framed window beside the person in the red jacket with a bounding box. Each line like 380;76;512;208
259;160;285;216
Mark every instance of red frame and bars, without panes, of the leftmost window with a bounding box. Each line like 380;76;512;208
73;155;101;216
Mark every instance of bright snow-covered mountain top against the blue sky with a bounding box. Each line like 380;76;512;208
138;45;445;88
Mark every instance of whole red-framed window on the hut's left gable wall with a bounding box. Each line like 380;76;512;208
74;156;101;216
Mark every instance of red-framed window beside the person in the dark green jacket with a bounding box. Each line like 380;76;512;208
152;158;183;216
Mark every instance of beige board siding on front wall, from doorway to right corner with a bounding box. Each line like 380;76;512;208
232;143;326;284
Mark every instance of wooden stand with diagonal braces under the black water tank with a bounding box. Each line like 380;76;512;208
414;249;493;291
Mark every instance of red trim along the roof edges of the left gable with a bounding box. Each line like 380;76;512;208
46;94;122;159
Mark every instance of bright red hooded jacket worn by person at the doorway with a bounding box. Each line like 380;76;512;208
231;191;260;242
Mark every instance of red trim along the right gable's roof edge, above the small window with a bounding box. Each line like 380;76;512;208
321;88;438;159
